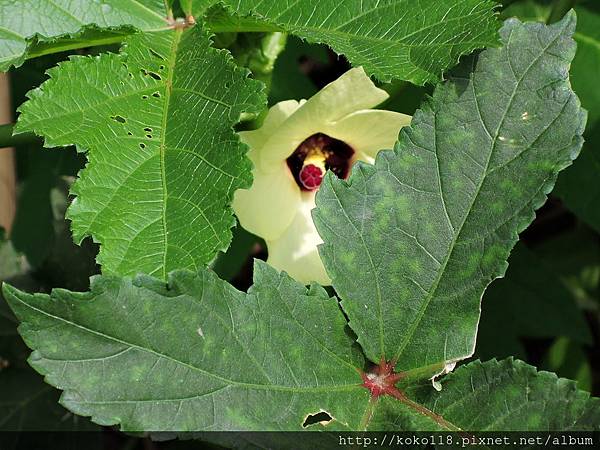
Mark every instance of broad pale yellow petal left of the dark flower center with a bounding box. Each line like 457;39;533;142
233;161;301;240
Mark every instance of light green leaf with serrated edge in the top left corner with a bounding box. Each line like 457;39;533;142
0;0;167;72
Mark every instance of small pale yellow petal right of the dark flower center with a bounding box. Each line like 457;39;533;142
328;109;412;164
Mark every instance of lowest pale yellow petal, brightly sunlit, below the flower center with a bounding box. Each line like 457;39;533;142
267;192;331;286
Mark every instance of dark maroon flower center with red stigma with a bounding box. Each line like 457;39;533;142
287;133;354;191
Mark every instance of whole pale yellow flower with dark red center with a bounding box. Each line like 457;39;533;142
233;67;411;285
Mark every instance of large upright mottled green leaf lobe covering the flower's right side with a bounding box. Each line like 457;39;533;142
313;15;585;370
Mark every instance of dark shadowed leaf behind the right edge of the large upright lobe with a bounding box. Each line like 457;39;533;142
477;241;592;359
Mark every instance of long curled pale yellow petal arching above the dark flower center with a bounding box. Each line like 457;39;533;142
260;67;388;171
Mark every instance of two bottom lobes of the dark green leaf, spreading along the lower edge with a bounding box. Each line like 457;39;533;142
4;262;600;432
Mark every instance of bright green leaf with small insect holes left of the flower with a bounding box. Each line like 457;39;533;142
17;25;264;279
